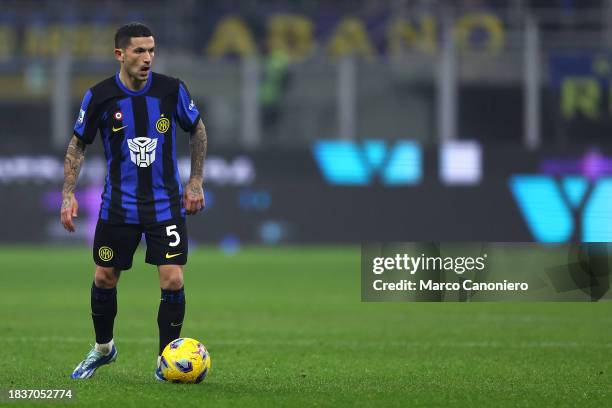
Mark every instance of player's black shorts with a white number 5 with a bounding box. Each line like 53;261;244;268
93;219;188;270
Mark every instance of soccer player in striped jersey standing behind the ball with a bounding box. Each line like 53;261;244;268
61;23;207;380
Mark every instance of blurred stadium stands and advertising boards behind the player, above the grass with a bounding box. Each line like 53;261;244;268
0;0;612;247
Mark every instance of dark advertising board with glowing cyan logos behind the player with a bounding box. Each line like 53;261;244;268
0;140;612;244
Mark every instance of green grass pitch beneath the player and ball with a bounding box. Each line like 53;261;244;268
0;247;612;408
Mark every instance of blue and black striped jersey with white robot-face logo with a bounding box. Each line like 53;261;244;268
74;73;200;224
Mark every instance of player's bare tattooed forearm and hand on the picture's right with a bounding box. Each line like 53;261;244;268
183;119;208;214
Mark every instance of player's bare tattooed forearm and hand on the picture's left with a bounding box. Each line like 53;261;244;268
61;136;85;232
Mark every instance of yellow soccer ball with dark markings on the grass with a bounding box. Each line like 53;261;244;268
160;338;211;384
